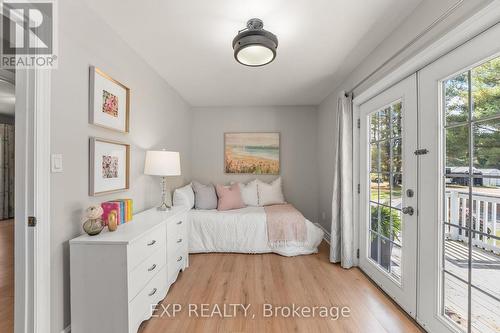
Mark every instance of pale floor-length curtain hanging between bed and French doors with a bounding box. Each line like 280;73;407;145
330;93;354;268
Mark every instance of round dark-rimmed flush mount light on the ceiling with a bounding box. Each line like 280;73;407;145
233;18;278;67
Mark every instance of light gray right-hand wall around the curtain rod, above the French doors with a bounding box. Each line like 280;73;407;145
317;0;491;230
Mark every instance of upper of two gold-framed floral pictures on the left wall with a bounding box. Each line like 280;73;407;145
89;66;130;133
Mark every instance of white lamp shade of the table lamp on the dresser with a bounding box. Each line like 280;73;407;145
144;150;181;177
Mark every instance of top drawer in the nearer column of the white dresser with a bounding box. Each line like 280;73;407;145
127;225;166;272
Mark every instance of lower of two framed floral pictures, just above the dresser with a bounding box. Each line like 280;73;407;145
89;138;130;196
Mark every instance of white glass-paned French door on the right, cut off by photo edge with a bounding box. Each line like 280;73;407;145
418;25;500;333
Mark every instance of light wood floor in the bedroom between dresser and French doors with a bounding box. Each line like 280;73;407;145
139;243;420;333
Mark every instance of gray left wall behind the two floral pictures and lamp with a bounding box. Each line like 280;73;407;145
51;0;191;333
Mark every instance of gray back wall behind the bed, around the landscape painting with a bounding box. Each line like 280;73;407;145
191;107;318;222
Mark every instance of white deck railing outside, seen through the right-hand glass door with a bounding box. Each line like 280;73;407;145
445;189;500;254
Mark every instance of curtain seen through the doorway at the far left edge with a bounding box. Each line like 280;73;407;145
0;124;14;220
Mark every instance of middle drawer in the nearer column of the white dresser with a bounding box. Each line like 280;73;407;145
128;248;167;301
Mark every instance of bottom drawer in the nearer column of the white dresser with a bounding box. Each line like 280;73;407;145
129;266;168;327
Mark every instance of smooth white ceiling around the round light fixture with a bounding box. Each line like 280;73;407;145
86;0;420;106
